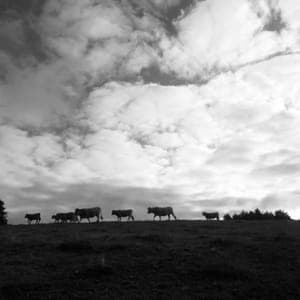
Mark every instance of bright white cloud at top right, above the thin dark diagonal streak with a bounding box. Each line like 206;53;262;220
161;0;299;81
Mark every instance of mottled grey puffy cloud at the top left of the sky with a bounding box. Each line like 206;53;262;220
40;0;164;85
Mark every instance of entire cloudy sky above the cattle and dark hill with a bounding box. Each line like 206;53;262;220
0;0;300;224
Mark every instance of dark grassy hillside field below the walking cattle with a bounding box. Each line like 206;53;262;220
0;221;300;299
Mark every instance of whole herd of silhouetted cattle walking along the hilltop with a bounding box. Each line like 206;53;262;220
25;206;219;224
